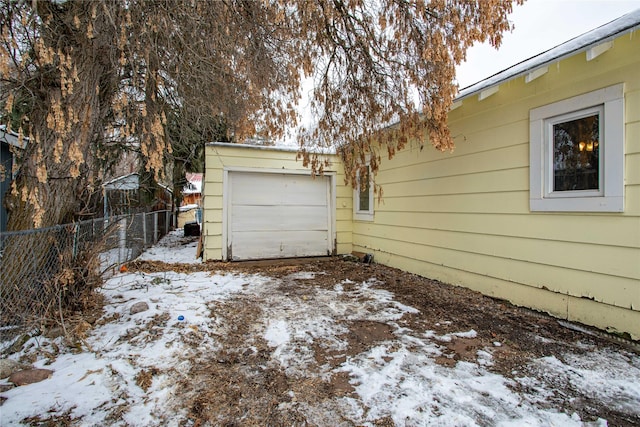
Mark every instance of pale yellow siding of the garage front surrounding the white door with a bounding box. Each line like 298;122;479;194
203;143;352;260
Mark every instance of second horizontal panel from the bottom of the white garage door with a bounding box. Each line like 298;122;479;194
231;205;328;232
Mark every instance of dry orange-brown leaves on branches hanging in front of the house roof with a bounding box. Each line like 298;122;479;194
299;0;512;187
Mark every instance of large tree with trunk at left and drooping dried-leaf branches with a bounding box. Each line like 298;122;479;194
0;0;511;229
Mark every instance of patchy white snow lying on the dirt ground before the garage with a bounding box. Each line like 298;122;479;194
0;233;640;426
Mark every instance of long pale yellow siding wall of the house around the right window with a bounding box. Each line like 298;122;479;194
353;33;640;339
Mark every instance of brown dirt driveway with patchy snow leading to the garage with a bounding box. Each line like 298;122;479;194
0;259;640;426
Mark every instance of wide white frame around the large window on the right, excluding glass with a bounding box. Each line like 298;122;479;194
529;83;624;212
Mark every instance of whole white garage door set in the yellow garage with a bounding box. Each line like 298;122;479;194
227;172;332;260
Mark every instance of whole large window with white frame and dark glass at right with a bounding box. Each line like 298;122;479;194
529;84;624;212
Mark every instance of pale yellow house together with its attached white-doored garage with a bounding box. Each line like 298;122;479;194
203;10;640;339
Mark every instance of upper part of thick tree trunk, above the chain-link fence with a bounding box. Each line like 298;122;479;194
5;2;118;230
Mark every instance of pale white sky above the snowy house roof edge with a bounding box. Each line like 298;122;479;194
456;0;640;89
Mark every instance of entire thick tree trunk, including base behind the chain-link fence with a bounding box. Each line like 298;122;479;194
0;2;118;334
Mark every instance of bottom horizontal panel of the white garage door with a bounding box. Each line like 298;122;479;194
232;231;328;260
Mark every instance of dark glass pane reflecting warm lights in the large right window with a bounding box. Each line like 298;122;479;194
553;114;600;191
